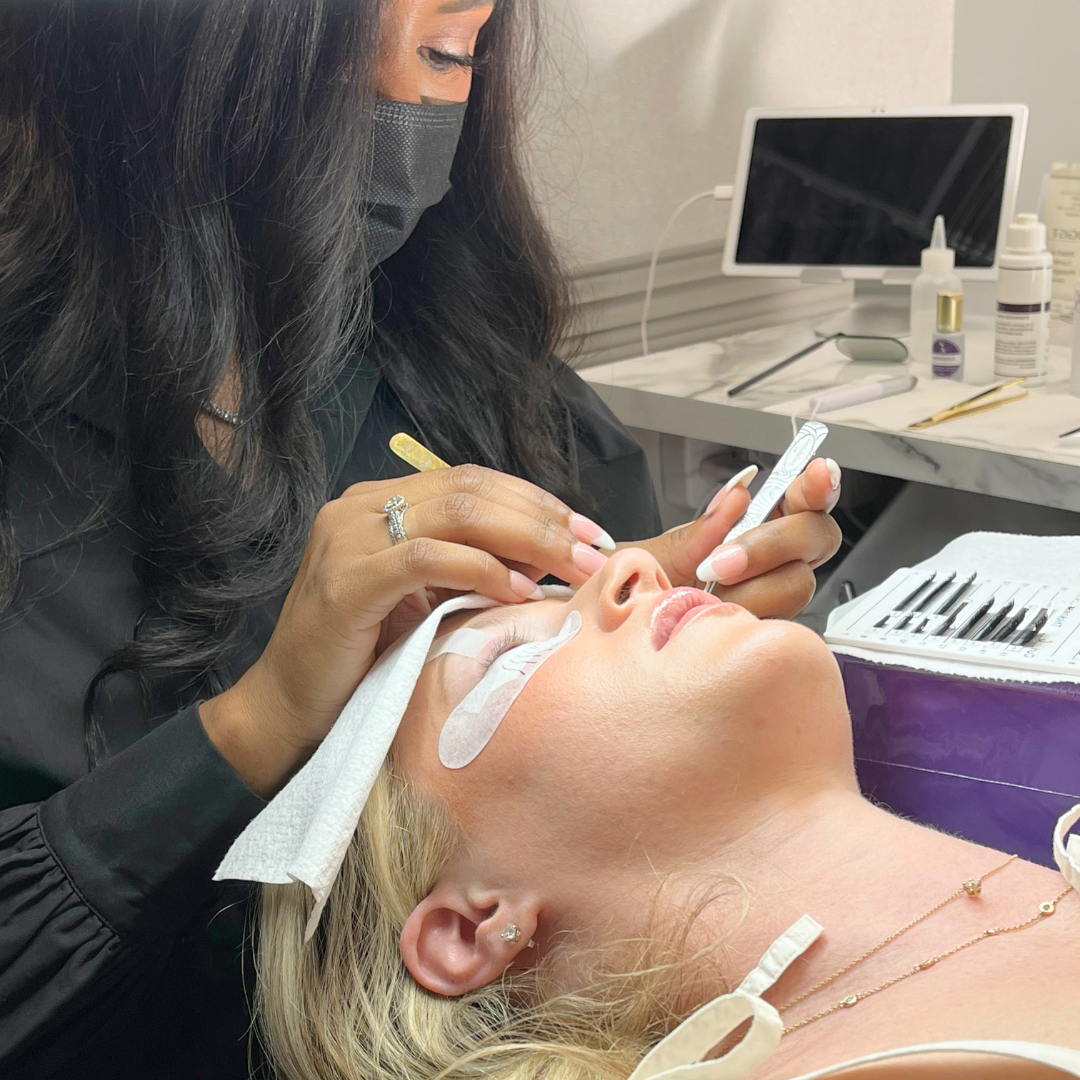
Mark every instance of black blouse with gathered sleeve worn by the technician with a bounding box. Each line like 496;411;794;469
0;364;660;1080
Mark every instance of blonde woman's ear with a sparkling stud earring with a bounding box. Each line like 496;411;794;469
401;882;540;998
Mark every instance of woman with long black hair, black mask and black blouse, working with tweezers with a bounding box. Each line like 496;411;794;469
0;0;840;1080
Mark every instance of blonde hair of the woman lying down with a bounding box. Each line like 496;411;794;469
257;764;738;1080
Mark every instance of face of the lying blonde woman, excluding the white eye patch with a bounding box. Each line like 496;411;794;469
395;550;851;993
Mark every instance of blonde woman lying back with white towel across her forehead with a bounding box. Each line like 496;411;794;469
218;550;1080;1080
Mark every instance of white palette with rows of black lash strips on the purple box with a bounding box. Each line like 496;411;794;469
825;570;1080;677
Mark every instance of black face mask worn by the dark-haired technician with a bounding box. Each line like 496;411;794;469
364;98;469;262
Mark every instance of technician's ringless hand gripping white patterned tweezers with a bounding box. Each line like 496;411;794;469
635;458;840;619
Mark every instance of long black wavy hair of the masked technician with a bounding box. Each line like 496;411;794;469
0;0;575;762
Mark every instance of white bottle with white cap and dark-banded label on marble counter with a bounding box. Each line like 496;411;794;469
994;214;1054;387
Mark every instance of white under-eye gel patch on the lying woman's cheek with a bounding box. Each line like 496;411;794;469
438;611;581;769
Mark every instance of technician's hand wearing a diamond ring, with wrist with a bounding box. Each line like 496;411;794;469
200;465;613;795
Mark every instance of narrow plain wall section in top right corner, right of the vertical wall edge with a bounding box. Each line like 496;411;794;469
953;0;1080;211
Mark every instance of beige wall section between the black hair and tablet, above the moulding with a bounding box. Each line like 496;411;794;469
535;0;954;266
